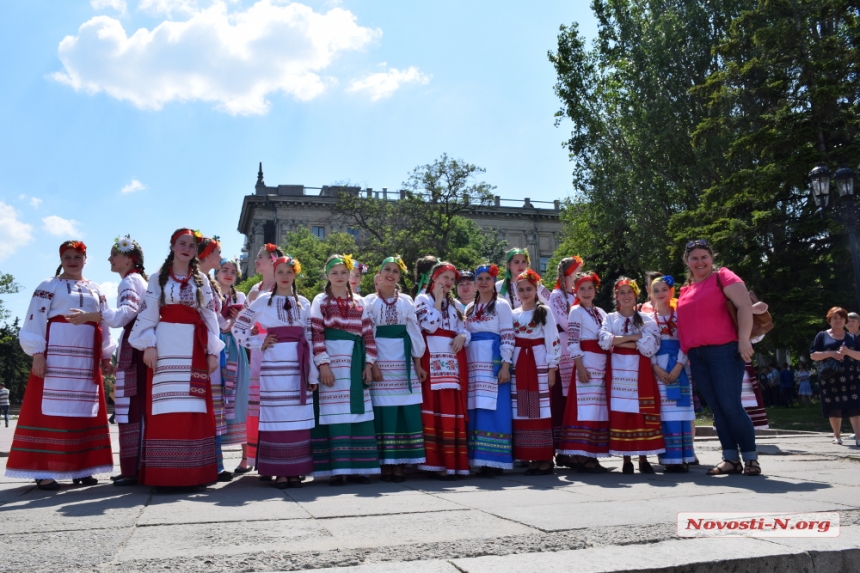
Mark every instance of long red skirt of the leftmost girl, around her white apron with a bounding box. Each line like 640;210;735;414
6;370;113;480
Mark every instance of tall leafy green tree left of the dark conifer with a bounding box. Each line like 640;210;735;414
548;0;737;300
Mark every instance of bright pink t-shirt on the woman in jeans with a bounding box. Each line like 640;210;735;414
678;268;743;352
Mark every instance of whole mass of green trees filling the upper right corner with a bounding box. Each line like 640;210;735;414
549;0;860;351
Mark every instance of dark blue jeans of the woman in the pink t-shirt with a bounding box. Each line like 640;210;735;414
687;342;758;462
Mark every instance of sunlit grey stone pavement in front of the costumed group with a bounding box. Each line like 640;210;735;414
0;425;860;573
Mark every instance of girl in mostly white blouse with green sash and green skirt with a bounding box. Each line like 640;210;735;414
364;257;427;483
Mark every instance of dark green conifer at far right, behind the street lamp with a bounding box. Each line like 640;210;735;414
670;0;860;353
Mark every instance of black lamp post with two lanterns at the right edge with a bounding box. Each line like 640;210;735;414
809;161;860;312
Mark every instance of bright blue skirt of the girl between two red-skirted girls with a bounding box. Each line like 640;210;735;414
468;382;514;469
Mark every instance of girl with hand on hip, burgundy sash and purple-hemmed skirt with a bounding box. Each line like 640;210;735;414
233;255;319;489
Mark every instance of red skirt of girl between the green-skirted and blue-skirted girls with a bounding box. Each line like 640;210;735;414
418;383;470;475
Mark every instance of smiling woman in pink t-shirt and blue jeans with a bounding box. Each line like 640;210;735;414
677;239;761;476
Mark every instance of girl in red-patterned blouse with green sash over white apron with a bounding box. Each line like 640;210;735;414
311;255;380;485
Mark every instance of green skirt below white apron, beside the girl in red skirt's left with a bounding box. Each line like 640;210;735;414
373;404;425;465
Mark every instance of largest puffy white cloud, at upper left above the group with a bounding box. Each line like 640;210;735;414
53;0;382;115
